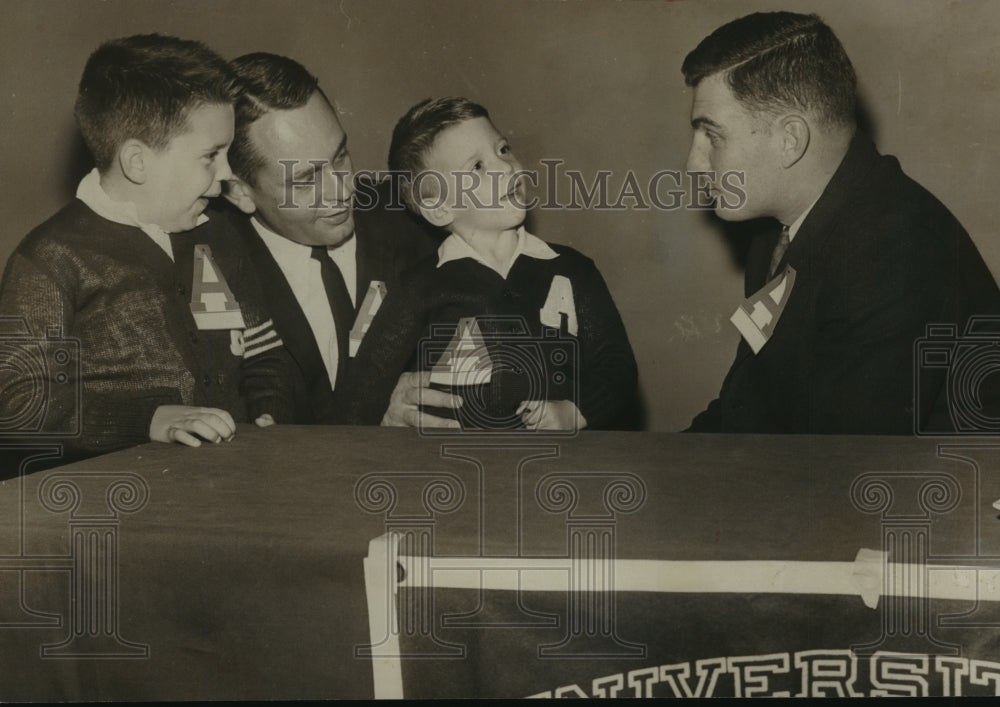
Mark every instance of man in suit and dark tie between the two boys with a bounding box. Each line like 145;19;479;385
215;53;455;425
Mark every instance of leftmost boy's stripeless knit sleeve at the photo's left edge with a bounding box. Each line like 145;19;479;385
0;252;181;456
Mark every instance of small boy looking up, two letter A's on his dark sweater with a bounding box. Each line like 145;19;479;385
338;98;637;431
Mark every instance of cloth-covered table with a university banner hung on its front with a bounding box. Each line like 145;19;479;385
0;426;1000;701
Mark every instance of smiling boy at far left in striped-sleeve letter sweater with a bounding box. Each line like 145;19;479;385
0;35;290;458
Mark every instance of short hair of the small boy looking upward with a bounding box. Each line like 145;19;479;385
389;97;490;214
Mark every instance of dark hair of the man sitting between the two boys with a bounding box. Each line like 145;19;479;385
229;52;325;186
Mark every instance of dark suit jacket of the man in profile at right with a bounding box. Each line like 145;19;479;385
689;130;1000;434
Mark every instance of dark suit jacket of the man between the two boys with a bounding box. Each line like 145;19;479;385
206;183;438;424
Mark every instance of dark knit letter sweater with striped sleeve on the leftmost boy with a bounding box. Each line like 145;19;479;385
0;200;290;457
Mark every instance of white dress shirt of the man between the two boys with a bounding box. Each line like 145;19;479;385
250;218;358;386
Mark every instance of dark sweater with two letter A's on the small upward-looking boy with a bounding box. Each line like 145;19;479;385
335;236;638;429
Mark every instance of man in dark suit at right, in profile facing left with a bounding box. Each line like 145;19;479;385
682;12;1000;434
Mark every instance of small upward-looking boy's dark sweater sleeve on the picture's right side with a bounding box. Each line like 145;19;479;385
574;258;638;429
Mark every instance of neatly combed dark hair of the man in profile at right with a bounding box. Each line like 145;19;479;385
681;12;857;125
